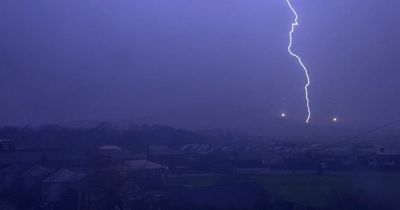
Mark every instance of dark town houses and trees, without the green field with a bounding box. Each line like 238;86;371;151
0;134;400;210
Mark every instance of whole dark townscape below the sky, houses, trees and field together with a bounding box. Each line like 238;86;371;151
0;123;400;210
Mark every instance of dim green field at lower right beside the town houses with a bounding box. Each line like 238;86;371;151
170;173;400;207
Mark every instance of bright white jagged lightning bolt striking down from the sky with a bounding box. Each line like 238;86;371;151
286;0;311;123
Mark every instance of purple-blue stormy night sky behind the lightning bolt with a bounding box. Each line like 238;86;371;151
0;0;400;132
